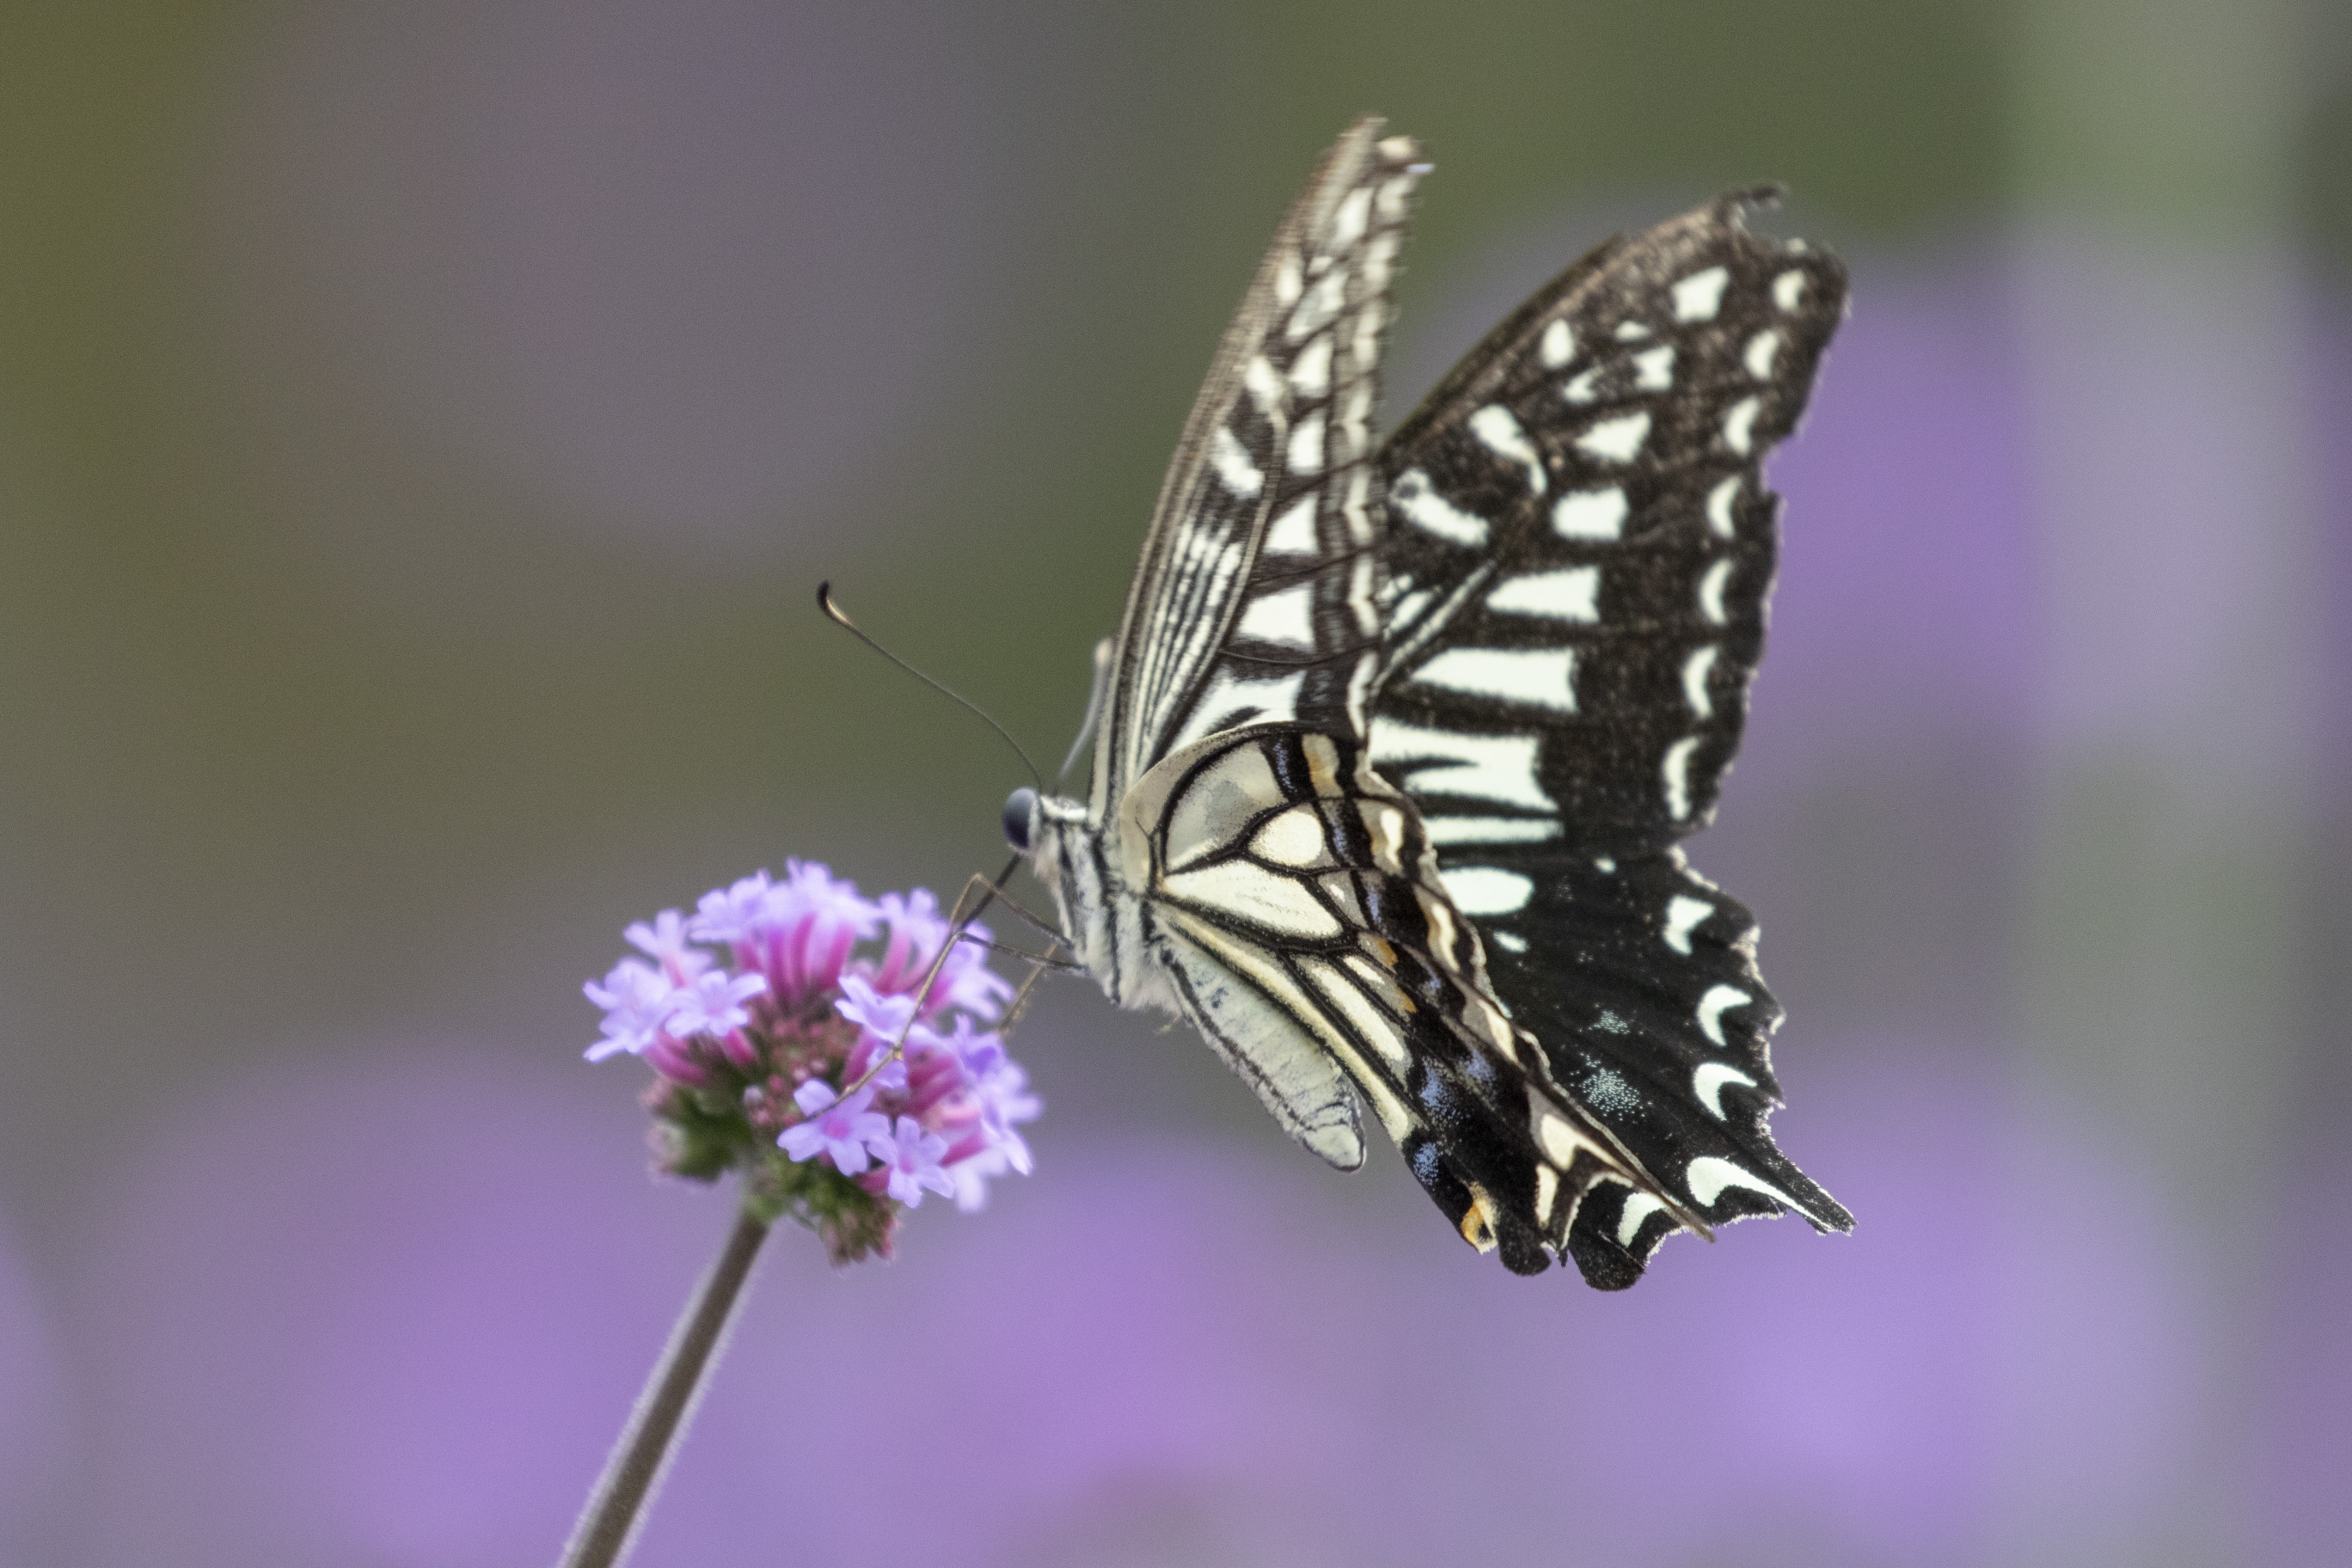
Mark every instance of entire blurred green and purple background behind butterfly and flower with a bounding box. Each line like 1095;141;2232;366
0;0;2352;1568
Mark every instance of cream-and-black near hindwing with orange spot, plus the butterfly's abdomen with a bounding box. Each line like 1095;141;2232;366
1119;724;1698;1274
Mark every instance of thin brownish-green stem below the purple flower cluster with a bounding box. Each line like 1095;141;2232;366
557;1210;767;1568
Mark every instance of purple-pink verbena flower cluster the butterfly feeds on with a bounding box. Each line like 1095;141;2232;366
585;861;1042;1262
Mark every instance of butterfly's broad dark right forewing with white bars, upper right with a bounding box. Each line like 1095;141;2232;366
1371;198;1844;854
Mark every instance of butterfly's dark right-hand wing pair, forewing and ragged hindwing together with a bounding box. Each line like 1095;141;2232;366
1371;193;1853;1286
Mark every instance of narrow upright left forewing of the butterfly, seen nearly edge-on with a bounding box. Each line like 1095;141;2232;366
1093;118;1423;818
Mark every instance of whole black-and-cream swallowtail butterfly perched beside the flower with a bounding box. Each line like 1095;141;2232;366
1007;119;1853;1289
